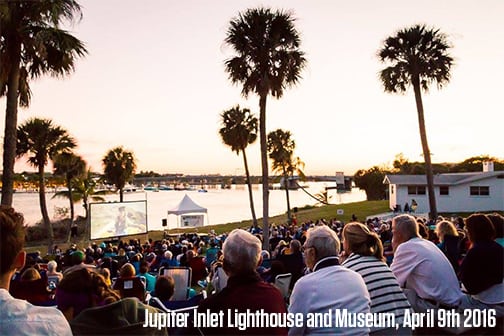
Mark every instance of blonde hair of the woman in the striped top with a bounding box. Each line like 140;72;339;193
343;222;385;261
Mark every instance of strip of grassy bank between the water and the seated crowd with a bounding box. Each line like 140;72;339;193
26;201;390;252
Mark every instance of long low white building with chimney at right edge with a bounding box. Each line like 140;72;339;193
383;162;504;213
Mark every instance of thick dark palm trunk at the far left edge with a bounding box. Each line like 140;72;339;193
1;52;21;206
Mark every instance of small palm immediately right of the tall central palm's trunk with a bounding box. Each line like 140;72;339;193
268;129;304;224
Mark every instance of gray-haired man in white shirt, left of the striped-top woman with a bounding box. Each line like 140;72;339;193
289;225;370;335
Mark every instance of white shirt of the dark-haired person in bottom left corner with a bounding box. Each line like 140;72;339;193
0;288;72;336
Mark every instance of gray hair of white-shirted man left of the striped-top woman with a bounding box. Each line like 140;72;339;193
305;225;340;261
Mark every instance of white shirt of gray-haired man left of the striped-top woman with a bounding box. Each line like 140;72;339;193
289;258;371;335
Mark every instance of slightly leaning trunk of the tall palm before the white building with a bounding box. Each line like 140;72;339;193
413;76;437;219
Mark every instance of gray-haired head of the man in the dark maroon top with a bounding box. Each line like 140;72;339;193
222;229;261;274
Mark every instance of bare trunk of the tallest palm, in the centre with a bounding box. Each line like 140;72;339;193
259;93;269;250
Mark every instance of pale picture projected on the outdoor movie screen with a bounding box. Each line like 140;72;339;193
89;201;147;240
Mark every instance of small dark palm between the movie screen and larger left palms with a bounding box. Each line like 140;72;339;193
54;152;86;242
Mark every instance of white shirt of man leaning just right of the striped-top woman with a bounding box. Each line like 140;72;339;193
390;238;463;306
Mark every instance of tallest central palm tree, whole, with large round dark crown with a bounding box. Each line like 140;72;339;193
225;8;306;249
